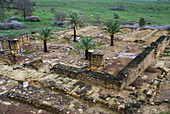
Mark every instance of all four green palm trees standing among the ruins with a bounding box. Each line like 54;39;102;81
37;11;123;60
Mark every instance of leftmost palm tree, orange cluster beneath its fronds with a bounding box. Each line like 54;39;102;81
35;27;56;52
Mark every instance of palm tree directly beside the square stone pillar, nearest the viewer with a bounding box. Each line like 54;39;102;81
77;36;96;60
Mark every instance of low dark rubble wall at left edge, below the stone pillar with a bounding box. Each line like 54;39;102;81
0;51;17;64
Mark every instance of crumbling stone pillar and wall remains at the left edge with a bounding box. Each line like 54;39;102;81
0;34;32;64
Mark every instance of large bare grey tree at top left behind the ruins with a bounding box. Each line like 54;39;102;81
13;0;34;19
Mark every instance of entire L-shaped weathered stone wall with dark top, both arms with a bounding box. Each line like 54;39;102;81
51;36;170;90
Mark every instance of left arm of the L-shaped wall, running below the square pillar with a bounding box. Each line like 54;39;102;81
51;64;121;89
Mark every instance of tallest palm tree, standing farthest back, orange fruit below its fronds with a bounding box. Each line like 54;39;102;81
66;11;85;42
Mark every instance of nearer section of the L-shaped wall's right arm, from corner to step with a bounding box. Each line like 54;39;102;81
116;47;155;89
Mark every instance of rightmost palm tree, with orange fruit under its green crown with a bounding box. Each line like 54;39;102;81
104;21;123;46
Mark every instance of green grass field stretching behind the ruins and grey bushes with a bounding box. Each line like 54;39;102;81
1;0;170;36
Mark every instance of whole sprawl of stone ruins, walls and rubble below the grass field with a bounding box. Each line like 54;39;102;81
0;26;170;114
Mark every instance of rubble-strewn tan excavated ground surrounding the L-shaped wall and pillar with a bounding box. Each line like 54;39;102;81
0;26;170;114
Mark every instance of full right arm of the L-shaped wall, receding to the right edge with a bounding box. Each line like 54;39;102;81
116;36;170;89
